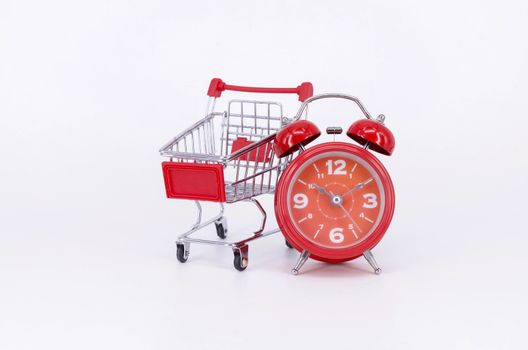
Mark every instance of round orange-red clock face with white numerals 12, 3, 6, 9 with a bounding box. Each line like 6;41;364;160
286;151;385;249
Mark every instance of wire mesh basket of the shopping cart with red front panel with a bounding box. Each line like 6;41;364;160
160;81;312;203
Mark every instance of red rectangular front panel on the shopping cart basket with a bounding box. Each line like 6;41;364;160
161;162;225;202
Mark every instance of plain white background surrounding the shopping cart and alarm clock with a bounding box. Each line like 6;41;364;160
0;0;528;350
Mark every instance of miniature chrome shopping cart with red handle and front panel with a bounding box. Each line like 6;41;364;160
160;78;313;271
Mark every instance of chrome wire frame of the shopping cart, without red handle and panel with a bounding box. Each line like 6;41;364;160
160;98;300;268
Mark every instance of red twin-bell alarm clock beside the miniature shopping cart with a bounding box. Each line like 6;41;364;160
274;94;395;274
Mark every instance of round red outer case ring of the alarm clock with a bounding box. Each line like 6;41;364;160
275;142;395;263
